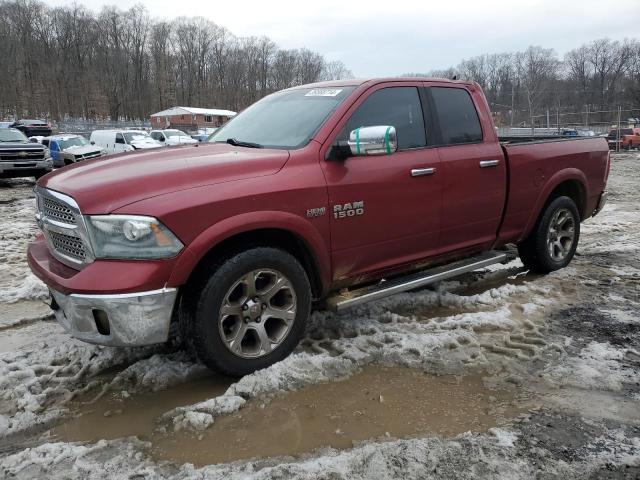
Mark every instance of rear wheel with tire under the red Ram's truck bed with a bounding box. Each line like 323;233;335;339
518;196;580;273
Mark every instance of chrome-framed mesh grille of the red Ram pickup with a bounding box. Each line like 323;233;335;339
35;187;93;268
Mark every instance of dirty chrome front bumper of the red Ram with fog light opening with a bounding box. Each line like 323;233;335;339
50;288;178;347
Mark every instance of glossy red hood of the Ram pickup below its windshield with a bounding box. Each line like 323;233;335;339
38;143;289;214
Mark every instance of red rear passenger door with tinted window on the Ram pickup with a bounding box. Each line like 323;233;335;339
427;85;507;253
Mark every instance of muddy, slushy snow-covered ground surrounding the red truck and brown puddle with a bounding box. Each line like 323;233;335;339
0;155;640;479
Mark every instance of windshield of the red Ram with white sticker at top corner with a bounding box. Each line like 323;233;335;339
209;87;355;149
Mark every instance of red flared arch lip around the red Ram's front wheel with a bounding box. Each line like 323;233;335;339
168;211;331;292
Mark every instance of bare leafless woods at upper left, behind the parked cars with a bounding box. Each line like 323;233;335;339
0;0;351;120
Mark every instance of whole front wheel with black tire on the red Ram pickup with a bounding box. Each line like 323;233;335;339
181;247;312;377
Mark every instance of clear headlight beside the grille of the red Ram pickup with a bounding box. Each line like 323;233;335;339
86;215;183;259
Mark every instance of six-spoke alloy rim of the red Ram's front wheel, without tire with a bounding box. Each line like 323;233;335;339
218;269;296;358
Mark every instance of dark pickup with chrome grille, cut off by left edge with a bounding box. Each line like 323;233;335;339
0;128;53;179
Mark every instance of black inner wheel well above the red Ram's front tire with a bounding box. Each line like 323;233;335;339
188;228;322;298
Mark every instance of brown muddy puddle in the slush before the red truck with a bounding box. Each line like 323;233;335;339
53;366;517;466
